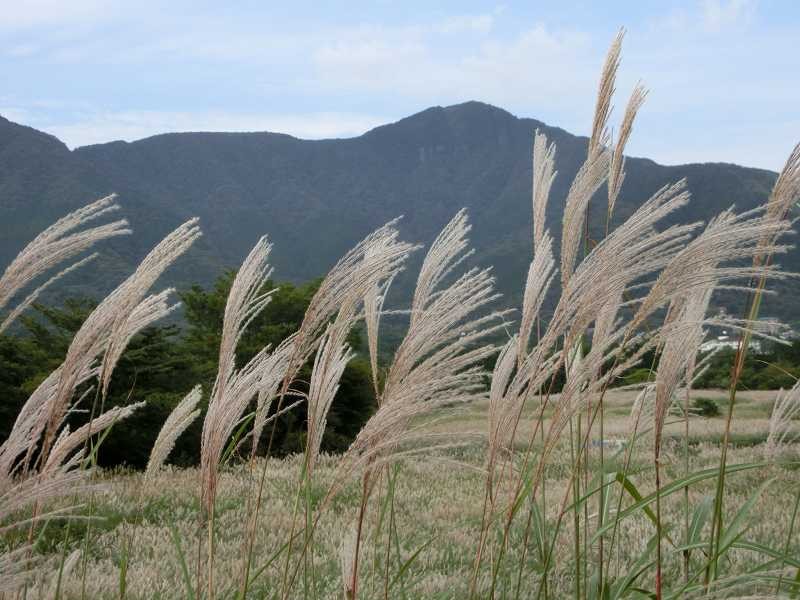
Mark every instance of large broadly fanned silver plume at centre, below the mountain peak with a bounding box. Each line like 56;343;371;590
340;210;504;482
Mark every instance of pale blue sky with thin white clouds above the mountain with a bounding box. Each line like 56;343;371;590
0;0;800;170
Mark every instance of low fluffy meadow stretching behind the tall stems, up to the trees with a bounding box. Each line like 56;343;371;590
7;390;800;600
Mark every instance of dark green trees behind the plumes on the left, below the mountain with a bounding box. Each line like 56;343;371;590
0;272;375;468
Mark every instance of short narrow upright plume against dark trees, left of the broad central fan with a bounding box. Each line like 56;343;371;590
306;304;356;477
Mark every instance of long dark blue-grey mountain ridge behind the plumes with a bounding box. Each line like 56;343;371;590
0;102;800;328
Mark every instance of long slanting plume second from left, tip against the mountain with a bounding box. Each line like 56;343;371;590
42;219;200;459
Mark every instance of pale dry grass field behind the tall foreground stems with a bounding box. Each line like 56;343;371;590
18;398;800;600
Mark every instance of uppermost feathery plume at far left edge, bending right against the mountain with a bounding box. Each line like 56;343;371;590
0;194;131;318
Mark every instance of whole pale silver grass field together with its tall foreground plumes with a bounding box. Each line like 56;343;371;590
0;33;800;600
